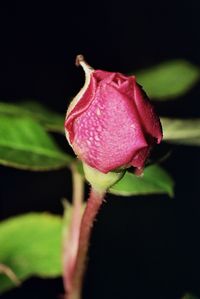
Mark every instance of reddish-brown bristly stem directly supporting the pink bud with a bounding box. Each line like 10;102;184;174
67;189;104;299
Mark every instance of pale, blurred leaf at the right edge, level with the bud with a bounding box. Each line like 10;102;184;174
161;117;200;146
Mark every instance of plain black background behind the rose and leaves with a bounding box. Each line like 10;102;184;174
0;0;200;299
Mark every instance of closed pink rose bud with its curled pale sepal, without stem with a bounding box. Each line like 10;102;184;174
65;55;162;173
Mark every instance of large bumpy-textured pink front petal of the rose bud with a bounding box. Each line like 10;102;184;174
73;82;147;173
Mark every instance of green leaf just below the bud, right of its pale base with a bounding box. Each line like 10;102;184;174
109;165;174;197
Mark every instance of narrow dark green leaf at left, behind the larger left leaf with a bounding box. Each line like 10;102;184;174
0;101;64;133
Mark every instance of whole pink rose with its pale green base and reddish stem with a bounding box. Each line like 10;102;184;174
65;55;162;298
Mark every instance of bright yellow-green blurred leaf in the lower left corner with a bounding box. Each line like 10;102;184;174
0;213;62;293
